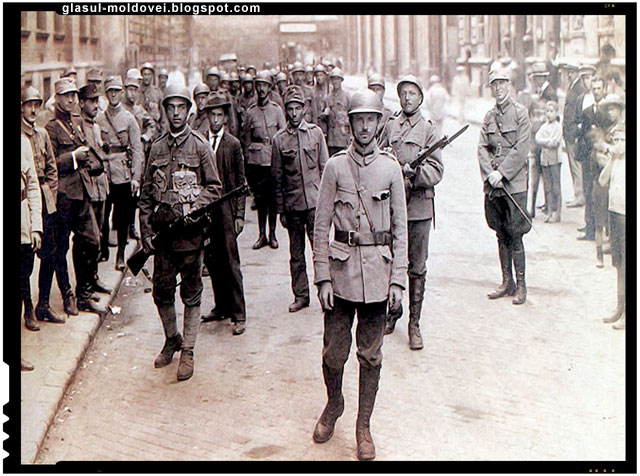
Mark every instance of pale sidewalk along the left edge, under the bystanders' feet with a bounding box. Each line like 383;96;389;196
20;236;137;464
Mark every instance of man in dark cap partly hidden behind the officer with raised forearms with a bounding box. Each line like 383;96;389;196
78;83;113;298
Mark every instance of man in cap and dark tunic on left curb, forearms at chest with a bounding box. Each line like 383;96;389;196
45;78;103;318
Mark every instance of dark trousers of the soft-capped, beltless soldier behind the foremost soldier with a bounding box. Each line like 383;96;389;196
285;208;316;301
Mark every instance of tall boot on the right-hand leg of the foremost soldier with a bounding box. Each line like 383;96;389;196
356;364;380;461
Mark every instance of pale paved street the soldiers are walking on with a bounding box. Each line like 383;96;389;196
30;113;626;463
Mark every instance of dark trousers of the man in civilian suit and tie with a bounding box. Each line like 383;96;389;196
204;202;247;322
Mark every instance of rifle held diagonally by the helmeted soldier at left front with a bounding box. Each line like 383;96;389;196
127;184;249;276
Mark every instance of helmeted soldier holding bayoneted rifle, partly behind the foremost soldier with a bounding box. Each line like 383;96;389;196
383;75;444;350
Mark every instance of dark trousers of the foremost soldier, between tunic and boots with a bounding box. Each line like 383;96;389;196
322;296;387;369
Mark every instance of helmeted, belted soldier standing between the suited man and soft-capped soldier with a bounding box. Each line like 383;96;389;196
243;70;286;250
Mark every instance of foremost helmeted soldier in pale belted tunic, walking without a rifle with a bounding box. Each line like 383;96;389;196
313;90;407;460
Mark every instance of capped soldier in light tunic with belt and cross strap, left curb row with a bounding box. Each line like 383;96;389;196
98;76;148;271
